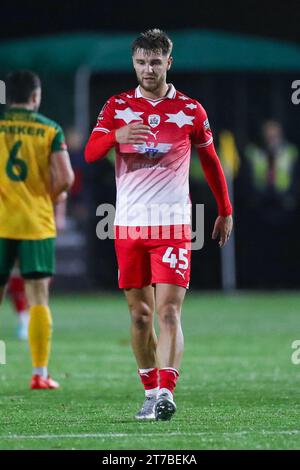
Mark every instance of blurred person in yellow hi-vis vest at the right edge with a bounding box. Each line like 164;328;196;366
236;120;300;288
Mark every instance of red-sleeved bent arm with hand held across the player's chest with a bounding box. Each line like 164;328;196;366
84;98;150;163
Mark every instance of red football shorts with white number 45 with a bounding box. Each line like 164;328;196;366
115;225;191;289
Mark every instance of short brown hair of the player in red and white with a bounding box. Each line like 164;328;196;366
132;28;173;56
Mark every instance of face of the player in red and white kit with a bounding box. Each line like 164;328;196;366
132;49;172;92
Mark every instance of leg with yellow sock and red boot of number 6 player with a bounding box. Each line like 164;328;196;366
25;278;59;389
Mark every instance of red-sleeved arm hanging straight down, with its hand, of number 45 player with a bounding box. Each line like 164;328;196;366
192;103;233;247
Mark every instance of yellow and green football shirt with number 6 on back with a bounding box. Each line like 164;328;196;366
0;108;66;240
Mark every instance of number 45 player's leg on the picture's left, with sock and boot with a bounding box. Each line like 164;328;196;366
125;286;158;420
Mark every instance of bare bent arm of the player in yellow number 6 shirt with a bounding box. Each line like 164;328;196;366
50;150;74;202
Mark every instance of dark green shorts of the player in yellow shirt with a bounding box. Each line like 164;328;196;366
0;238;55;285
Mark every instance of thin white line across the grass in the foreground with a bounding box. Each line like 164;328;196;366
0;429;300;441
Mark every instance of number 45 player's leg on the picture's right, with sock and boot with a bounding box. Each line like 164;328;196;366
155;284;186;420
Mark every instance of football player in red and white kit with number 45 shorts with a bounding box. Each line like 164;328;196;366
85;29;232;420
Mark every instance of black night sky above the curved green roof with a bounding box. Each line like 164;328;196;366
0;0;300;43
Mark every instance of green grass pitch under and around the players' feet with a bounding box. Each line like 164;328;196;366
0;292;300;450
